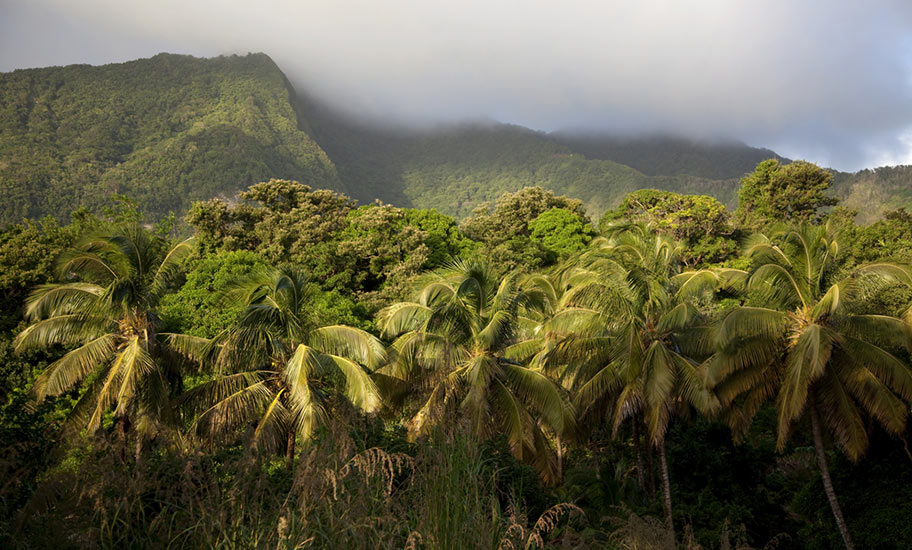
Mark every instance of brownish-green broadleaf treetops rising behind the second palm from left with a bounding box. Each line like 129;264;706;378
187;180;474;311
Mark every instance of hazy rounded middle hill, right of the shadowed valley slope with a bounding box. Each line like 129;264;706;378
384;126;748;216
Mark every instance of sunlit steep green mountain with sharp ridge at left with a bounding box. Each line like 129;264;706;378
0;54;340;222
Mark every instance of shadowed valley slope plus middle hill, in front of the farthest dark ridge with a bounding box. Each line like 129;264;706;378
302;101;753;221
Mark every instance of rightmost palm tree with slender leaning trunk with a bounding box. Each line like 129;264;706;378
712;225;912;549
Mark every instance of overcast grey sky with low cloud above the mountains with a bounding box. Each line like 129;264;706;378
0;0;912;170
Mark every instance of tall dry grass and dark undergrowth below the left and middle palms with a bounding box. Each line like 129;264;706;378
12;437;582;550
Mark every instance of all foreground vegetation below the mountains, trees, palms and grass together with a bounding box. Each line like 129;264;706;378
0;170;912;548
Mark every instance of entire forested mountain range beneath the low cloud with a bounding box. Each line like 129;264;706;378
0;54;912;222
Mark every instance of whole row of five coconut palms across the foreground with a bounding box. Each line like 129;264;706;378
17;225;912;548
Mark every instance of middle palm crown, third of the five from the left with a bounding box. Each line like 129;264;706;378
379;261;574;481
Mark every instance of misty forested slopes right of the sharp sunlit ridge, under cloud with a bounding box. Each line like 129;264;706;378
301;99;912;222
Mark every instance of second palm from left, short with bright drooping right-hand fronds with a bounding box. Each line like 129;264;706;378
171;266;385;469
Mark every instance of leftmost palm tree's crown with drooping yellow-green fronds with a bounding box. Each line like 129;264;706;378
16;224;192;446
